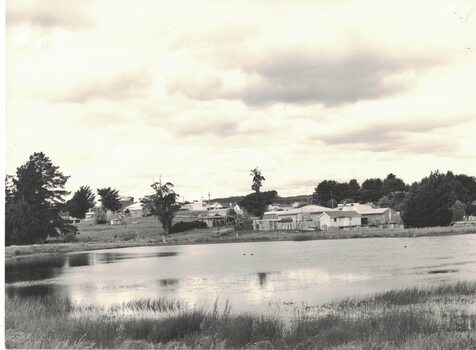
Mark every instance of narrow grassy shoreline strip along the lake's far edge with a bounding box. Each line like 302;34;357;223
5;227;476;264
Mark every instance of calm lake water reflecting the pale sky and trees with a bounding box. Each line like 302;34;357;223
5;235;476;312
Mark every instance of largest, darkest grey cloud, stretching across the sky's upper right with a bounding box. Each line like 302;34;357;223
169;49;438;106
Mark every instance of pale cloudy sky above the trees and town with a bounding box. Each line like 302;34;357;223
5;0;476;200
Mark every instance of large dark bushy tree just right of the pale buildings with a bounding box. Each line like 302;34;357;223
402;171;469;227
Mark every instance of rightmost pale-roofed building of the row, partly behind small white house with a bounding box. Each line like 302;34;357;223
337;203;404;228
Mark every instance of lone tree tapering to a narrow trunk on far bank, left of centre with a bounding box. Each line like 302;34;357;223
141;182;180;235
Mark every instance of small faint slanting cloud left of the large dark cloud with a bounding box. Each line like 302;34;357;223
53;73;151;103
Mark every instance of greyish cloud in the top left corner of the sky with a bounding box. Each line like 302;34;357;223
6;0;92;30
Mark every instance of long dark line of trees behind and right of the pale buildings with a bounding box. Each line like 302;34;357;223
312;171;476;227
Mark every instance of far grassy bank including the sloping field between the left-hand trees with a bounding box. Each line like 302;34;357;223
5;217;476;260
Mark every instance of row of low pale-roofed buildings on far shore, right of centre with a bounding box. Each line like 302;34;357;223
253;203;404;231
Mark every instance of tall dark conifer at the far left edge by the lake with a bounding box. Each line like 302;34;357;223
5;152;75;245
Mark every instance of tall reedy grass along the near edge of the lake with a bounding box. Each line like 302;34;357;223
5;282;476;349
